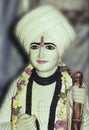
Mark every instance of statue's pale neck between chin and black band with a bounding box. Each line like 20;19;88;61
36;66;58;78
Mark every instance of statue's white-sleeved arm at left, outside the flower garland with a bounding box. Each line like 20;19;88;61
0;80;17;130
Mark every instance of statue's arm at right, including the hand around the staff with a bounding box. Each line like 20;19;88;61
73;84;89;130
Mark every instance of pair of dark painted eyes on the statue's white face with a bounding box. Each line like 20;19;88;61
30;43;56;50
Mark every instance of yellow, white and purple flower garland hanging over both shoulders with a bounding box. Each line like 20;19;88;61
11;65;72;130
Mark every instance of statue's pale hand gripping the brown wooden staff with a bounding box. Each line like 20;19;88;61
72;86;86;104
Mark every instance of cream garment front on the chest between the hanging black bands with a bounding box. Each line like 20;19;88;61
32;82;55;130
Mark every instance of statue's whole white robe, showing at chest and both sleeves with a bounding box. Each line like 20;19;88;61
0;77;89;130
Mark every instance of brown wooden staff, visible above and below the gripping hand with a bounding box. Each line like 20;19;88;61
71;72;83;130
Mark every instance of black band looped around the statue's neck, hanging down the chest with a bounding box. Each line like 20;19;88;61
26;68;61;130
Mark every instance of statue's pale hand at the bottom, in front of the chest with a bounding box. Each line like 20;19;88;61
17;114;36;130
